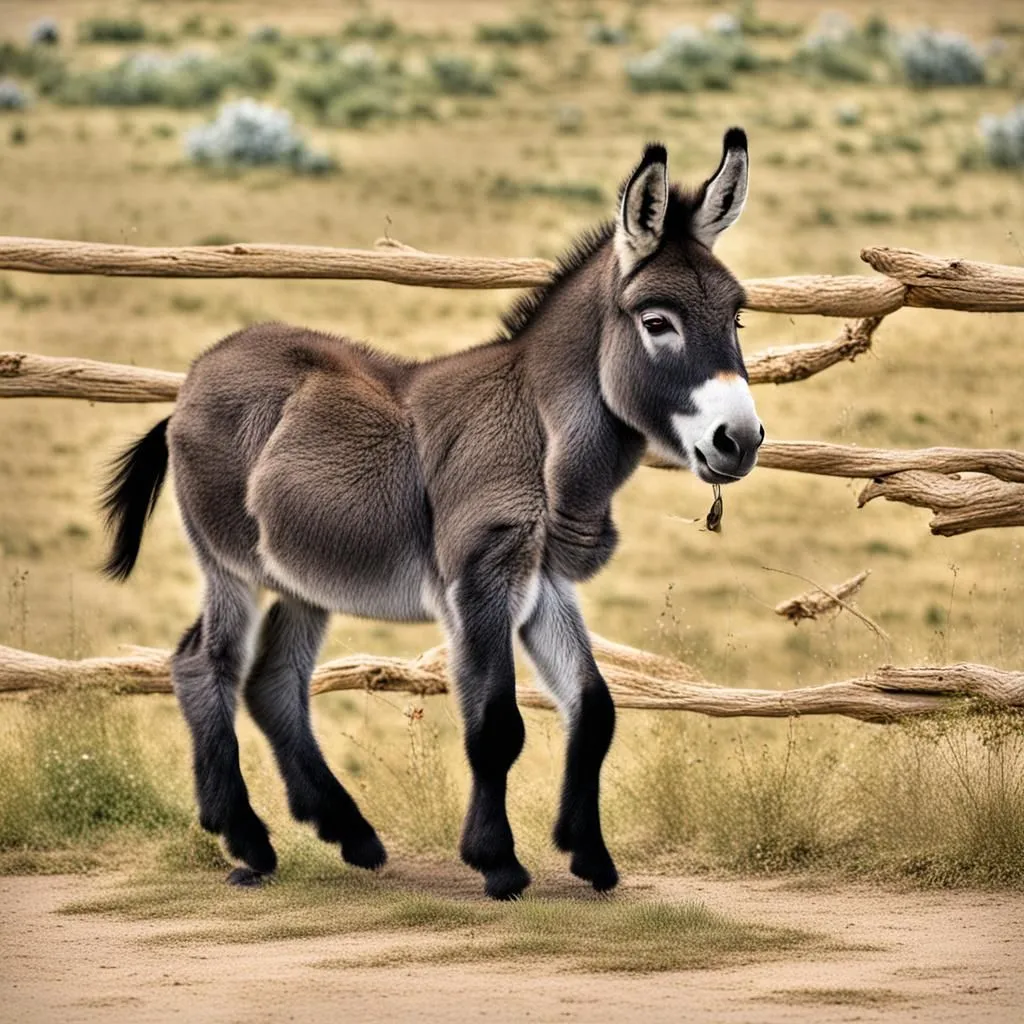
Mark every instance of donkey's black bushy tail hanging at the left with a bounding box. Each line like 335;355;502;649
100;417;171;581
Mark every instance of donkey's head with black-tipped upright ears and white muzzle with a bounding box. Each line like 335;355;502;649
601;128;764;483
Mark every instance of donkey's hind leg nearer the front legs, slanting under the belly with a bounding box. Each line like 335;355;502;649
245;598;387;868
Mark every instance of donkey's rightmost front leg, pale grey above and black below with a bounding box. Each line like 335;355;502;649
519;577;618;892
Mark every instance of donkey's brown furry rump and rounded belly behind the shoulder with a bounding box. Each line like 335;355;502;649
168;324;432;620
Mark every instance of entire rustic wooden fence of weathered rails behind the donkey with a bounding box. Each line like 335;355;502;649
0;238;1024;721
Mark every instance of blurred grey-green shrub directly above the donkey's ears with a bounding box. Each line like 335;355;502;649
626;25;759;92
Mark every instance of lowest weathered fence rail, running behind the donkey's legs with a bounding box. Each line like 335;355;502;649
0;637;1024;723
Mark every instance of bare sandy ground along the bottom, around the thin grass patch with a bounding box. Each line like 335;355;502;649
0;878;1024;1024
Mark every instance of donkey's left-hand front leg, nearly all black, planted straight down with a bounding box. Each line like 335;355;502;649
447;565;529;899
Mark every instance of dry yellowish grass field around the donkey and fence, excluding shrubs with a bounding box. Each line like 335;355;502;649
0;0;1024;1019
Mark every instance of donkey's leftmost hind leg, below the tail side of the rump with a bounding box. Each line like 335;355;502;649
171;567;278;885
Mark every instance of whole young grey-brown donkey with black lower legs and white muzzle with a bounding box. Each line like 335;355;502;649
103;128;764;899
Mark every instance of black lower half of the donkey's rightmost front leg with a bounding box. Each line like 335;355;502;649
554;679;618;891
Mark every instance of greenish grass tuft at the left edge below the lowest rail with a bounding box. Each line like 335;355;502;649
0;693;188;850
